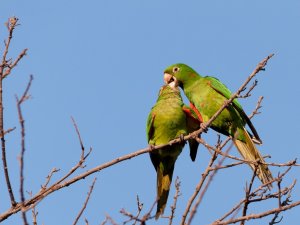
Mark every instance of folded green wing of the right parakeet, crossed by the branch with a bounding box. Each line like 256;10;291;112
205;76;262;144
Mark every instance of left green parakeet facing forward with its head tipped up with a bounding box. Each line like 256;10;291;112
146;83;199;219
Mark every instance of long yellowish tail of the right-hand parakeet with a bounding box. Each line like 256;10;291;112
233;128;273;189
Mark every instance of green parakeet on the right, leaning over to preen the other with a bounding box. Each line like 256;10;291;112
164;64;273;188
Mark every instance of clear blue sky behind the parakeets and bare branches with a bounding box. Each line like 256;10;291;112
0;0;300;225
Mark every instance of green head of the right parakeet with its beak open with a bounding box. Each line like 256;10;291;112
164;63;199;88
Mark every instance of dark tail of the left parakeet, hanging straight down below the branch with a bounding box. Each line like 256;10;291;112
155;159;175;219
